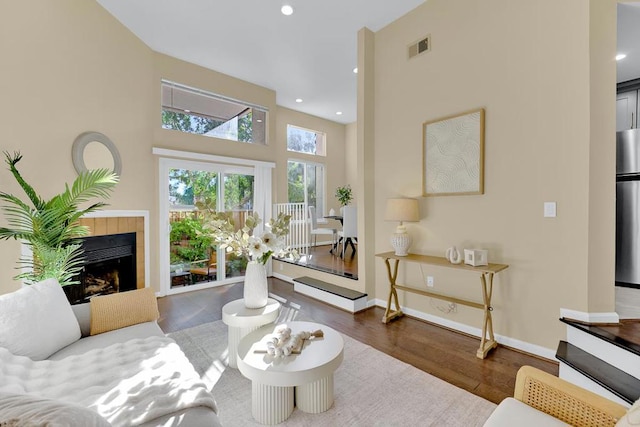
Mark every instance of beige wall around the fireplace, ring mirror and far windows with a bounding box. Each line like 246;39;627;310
0;0;345;294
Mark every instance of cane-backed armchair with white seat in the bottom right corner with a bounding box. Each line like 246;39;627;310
484;366;640;427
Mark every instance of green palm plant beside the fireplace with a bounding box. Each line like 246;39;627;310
0;152;118;286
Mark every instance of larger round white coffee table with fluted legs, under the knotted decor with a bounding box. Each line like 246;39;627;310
237;322;344;424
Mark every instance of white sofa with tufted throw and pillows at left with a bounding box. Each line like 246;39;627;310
0;281;220;427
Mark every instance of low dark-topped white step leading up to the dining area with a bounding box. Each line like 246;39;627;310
293;276;367;313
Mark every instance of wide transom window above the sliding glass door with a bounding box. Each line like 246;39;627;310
162;81;267;144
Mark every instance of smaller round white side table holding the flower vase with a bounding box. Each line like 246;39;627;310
222;298;280;369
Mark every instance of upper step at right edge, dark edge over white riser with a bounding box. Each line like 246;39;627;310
560;318;640;379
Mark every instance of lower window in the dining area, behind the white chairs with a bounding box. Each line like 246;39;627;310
287;160;325;221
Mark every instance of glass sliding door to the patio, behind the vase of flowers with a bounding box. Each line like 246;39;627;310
160;159;255;293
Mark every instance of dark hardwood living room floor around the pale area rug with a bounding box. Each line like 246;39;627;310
158;278;558;403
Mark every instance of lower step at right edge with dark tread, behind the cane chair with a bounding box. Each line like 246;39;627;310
556;341;640;405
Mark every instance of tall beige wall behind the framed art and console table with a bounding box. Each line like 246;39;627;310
374;0;615;349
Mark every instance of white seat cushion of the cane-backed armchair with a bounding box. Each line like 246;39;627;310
484;397;569;427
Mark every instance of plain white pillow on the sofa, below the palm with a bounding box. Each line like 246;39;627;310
0;279;80;360
